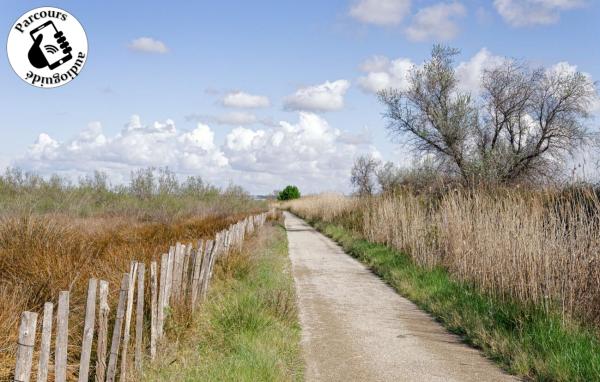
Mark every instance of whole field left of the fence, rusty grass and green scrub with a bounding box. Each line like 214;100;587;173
0;169;266;380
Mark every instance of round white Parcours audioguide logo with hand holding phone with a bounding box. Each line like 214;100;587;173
6;7;88;88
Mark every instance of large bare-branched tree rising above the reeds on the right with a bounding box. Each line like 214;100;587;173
379;45;597;183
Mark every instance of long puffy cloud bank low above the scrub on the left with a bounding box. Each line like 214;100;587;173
15;115;228;177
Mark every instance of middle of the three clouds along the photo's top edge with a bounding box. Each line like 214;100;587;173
406;2;467;41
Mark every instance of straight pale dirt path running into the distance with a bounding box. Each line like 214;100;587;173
285;213;516;382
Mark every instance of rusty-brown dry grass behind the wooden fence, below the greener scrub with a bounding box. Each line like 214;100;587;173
0;213;260;381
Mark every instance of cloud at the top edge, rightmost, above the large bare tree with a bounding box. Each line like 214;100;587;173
494;0;587;27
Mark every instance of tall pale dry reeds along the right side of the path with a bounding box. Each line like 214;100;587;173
287;190;600;325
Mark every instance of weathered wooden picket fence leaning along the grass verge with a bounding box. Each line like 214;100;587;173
14;213;267;382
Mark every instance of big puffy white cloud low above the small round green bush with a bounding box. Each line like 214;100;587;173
223;112;379;191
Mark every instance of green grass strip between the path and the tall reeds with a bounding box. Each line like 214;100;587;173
311;218;600;381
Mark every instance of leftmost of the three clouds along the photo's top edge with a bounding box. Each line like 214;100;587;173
349;0;411;26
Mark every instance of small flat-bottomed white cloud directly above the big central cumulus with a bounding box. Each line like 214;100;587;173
283;80;350;112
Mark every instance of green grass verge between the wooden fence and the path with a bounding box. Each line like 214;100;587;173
141;226;303;381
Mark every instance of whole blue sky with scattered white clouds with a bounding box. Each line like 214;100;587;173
0;0;600;194
